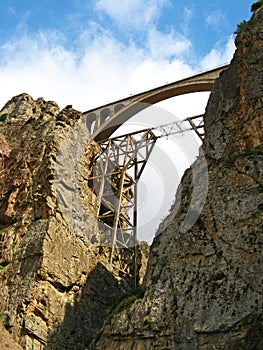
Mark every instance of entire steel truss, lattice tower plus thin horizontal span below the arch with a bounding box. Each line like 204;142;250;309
88;116;206;287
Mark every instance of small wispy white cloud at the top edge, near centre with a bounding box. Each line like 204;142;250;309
96;0;169;28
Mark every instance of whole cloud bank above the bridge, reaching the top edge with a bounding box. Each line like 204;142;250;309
0;0;234;111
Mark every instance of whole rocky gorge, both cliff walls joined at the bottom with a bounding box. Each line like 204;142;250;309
0;1;263;350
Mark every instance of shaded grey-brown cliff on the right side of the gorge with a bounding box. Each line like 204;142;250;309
92;6;263;350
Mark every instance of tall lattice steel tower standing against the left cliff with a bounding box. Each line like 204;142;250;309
89;129;157;288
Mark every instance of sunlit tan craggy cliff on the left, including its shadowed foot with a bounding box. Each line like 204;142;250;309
0;94;147;349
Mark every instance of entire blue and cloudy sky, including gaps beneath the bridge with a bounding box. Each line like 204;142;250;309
0;0;253;241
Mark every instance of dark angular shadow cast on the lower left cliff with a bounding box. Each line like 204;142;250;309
45;263;124;350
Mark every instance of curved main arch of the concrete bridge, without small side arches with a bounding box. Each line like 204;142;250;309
84;65;228;141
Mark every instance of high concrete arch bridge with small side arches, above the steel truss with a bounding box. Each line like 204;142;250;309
83;65;228;141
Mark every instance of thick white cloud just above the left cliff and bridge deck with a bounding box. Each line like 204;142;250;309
0;24;196;111
